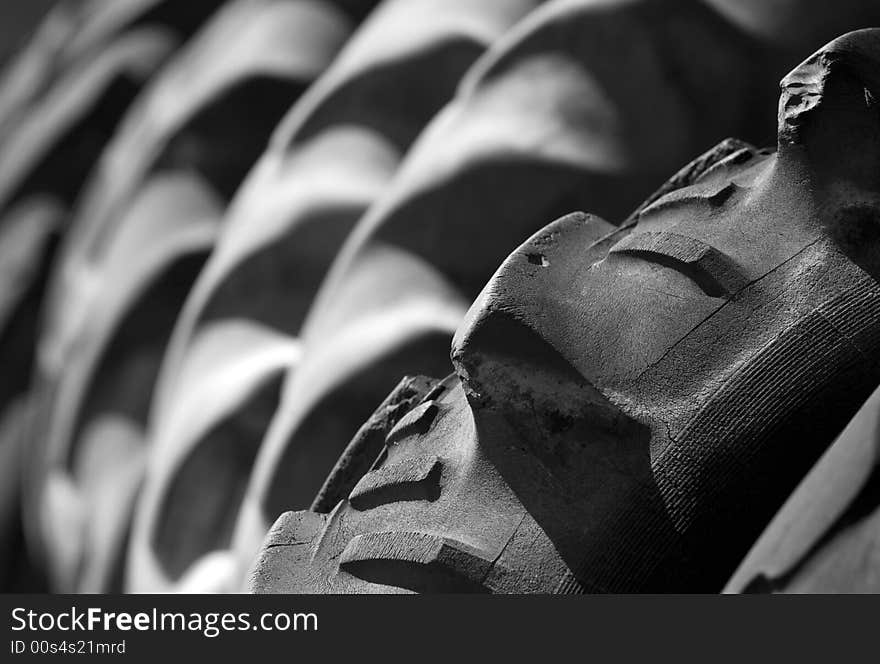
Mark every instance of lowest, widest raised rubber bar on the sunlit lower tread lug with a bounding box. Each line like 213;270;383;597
339;532;492;593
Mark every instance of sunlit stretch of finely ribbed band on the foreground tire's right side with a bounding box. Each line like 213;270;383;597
656;281;880;531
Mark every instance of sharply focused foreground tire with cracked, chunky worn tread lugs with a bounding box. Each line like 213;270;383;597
251;29;880;593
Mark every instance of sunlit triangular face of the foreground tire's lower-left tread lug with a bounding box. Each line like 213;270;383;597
251;376;580;593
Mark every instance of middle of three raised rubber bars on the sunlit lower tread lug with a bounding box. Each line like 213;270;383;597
348;457;443;510
